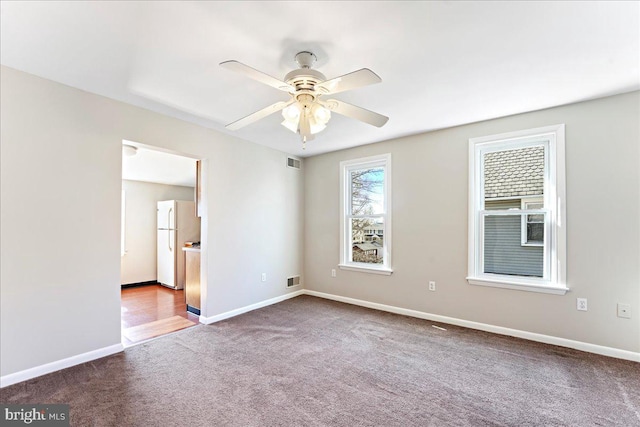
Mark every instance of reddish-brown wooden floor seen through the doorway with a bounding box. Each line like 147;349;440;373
121;285;198;347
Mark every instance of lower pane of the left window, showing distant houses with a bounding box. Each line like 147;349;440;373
350;221;384;264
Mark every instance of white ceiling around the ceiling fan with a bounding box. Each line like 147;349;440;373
0;1;640;157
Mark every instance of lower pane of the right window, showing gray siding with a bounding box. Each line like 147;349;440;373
483;214;544;277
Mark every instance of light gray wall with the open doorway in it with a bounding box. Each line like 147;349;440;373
0;67;304;376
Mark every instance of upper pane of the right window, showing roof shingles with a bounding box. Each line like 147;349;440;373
483;145;545;201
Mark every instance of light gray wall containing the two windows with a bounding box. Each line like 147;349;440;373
305;92;640;352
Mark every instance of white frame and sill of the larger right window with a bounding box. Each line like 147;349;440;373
467;124;569;295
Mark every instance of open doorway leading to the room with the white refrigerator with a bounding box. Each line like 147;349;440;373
121;141;200;347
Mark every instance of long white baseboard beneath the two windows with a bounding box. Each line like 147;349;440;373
304;289;640;362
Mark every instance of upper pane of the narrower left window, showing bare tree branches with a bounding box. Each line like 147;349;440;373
349;167;384;215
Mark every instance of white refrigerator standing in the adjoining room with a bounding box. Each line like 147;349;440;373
157;200;200;289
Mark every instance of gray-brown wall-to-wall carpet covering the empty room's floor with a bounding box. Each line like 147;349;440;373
0;296;640;426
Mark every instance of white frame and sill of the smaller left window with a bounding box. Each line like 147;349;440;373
338;153;393;275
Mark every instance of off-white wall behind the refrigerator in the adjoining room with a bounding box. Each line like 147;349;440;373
120;179;195;285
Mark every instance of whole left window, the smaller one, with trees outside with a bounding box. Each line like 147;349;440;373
340;154;392;275
